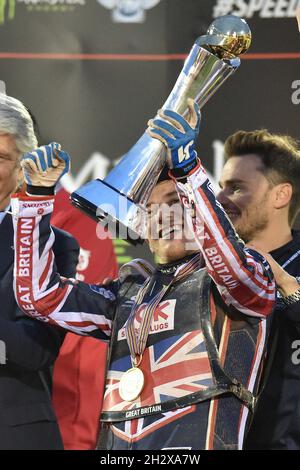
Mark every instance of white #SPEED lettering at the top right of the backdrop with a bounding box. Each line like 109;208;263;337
213;0;300;18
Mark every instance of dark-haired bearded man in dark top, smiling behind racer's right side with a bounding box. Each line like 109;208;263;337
218;130;300;449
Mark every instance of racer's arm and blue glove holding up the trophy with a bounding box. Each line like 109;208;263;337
148;100;275;317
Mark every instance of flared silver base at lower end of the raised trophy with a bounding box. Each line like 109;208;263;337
71;179;145;245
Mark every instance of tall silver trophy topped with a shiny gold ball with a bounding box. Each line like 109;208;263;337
71;15;251;244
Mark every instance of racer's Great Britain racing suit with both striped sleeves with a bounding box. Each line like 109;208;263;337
13;166;275;449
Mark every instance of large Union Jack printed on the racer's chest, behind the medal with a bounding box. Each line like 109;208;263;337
103;331;213;411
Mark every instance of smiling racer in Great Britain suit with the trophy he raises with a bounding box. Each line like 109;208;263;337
9;17;284;450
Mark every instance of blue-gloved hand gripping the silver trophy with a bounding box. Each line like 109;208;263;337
147;99;201;177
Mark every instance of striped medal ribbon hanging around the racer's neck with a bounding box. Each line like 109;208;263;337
125;253;201;367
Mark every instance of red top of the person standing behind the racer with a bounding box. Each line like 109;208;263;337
51;189;117;450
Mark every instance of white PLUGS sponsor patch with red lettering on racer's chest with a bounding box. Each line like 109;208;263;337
118;299;176;341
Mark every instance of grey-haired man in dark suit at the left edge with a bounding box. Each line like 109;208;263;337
0;94;79;449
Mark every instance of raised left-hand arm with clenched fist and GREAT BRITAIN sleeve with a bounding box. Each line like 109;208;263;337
12;143;116;340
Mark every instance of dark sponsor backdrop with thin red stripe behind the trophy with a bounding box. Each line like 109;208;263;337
0;0;300;263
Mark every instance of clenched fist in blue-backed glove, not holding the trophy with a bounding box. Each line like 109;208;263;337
20;142;70;188
